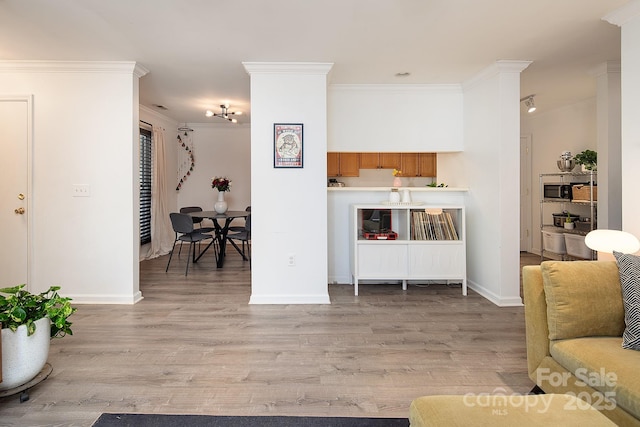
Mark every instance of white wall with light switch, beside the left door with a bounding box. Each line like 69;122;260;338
0;61;144;303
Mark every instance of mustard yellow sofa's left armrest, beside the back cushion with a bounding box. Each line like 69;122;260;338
522;265;550;382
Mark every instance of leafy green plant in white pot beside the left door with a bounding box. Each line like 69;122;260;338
0;285;77;390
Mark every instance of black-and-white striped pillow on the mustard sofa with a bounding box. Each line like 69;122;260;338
613;251;640;350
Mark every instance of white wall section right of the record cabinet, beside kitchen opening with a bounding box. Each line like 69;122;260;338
457;61;529;306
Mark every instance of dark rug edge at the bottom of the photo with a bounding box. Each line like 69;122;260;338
93;414;409;427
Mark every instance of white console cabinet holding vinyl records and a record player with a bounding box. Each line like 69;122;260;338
349;203;467;295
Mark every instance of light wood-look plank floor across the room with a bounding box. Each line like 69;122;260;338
0;249;533;426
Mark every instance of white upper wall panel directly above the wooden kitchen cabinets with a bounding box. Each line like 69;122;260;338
327;85;463;152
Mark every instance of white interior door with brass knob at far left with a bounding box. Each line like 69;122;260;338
0;96;32;288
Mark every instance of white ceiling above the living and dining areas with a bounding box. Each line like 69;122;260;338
0;0;627;123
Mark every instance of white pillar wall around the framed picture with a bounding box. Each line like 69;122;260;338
245;63;331;304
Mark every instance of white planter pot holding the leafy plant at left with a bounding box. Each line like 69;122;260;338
0;318;51;390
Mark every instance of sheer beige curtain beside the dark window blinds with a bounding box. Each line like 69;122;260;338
145;126;175;259
